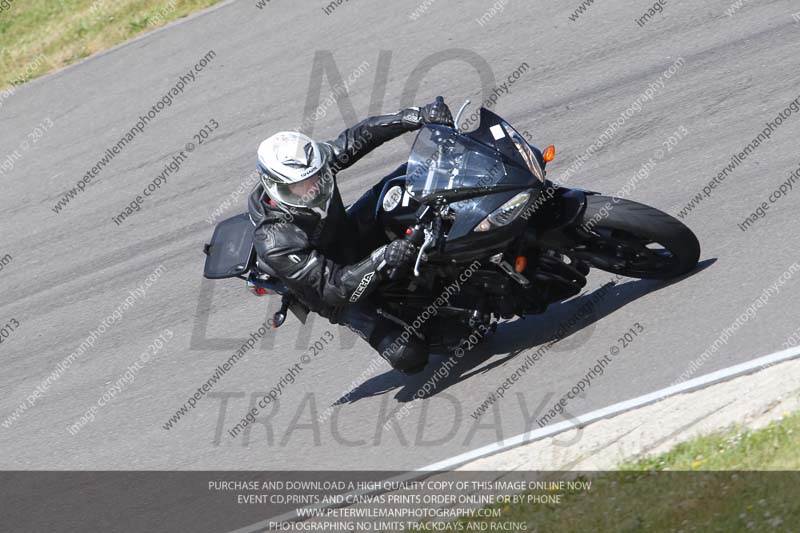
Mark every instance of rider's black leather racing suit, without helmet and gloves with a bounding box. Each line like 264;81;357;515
248;108;428;373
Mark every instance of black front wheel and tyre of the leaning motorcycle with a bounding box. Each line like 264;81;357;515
572;196;700;279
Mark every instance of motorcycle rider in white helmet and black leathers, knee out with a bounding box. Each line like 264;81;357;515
248;97;453;374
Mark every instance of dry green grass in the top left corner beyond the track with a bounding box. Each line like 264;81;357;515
0;0;221;89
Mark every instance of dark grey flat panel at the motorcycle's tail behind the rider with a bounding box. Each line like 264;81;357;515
203;214;256;279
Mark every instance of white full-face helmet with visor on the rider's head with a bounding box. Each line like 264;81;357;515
258;131;334;218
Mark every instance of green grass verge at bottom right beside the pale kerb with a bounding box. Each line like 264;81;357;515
446;414;800;532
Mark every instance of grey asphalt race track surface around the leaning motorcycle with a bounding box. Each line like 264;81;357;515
0;0;800;470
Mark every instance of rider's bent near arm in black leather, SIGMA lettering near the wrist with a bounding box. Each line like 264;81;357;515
255;223;383;306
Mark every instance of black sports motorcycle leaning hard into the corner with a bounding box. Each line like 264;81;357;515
205;104;700;348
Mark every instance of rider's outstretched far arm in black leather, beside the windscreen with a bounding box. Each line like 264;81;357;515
325;107;424;171
